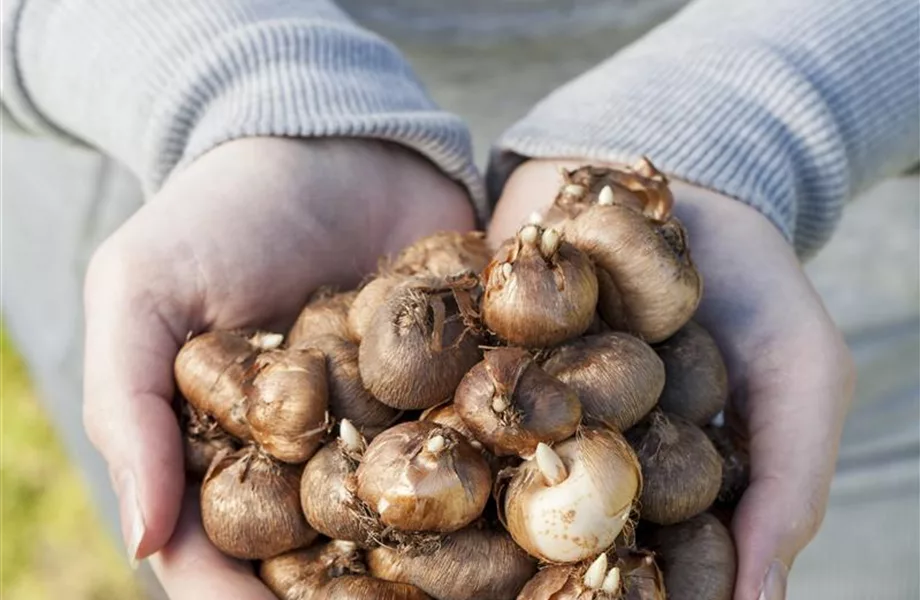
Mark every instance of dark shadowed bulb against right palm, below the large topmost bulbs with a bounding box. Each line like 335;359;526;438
655;321;728;427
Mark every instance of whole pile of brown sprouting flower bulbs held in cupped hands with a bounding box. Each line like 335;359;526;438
175;160;746;600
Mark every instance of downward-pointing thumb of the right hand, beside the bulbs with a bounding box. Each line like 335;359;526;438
733;328;853;600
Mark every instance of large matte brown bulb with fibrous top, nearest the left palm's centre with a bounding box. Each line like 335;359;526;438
358;279;481;410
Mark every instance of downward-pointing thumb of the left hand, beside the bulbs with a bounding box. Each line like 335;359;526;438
83;244;191;560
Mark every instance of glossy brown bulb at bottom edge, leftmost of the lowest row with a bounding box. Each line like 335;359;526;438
259;540;367;600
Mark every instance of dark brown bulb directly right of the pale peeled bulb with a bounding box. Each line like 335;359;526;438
626;410;722;525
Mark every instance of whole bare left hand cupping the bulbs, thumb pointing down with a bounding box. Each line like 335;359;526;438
84;138;473;600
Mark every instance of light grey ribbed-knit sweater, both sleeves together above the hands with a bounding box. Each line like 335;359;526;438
2;0;920;258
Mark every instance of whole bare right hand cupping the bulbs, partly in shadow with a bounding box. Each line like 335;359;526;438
490;160;854;600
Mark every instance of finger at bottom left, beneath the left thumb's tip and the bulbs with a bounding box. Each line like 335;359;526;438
150;490;275;600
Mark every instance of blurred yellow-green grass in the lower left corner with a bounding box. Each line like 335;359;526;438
0;322;142;600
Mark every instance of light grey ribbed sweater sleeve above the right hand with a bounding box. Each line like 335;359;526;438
487;0;920;258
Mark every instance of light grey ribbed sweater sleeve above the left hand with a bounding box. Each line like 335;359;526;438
2;0;485;212
